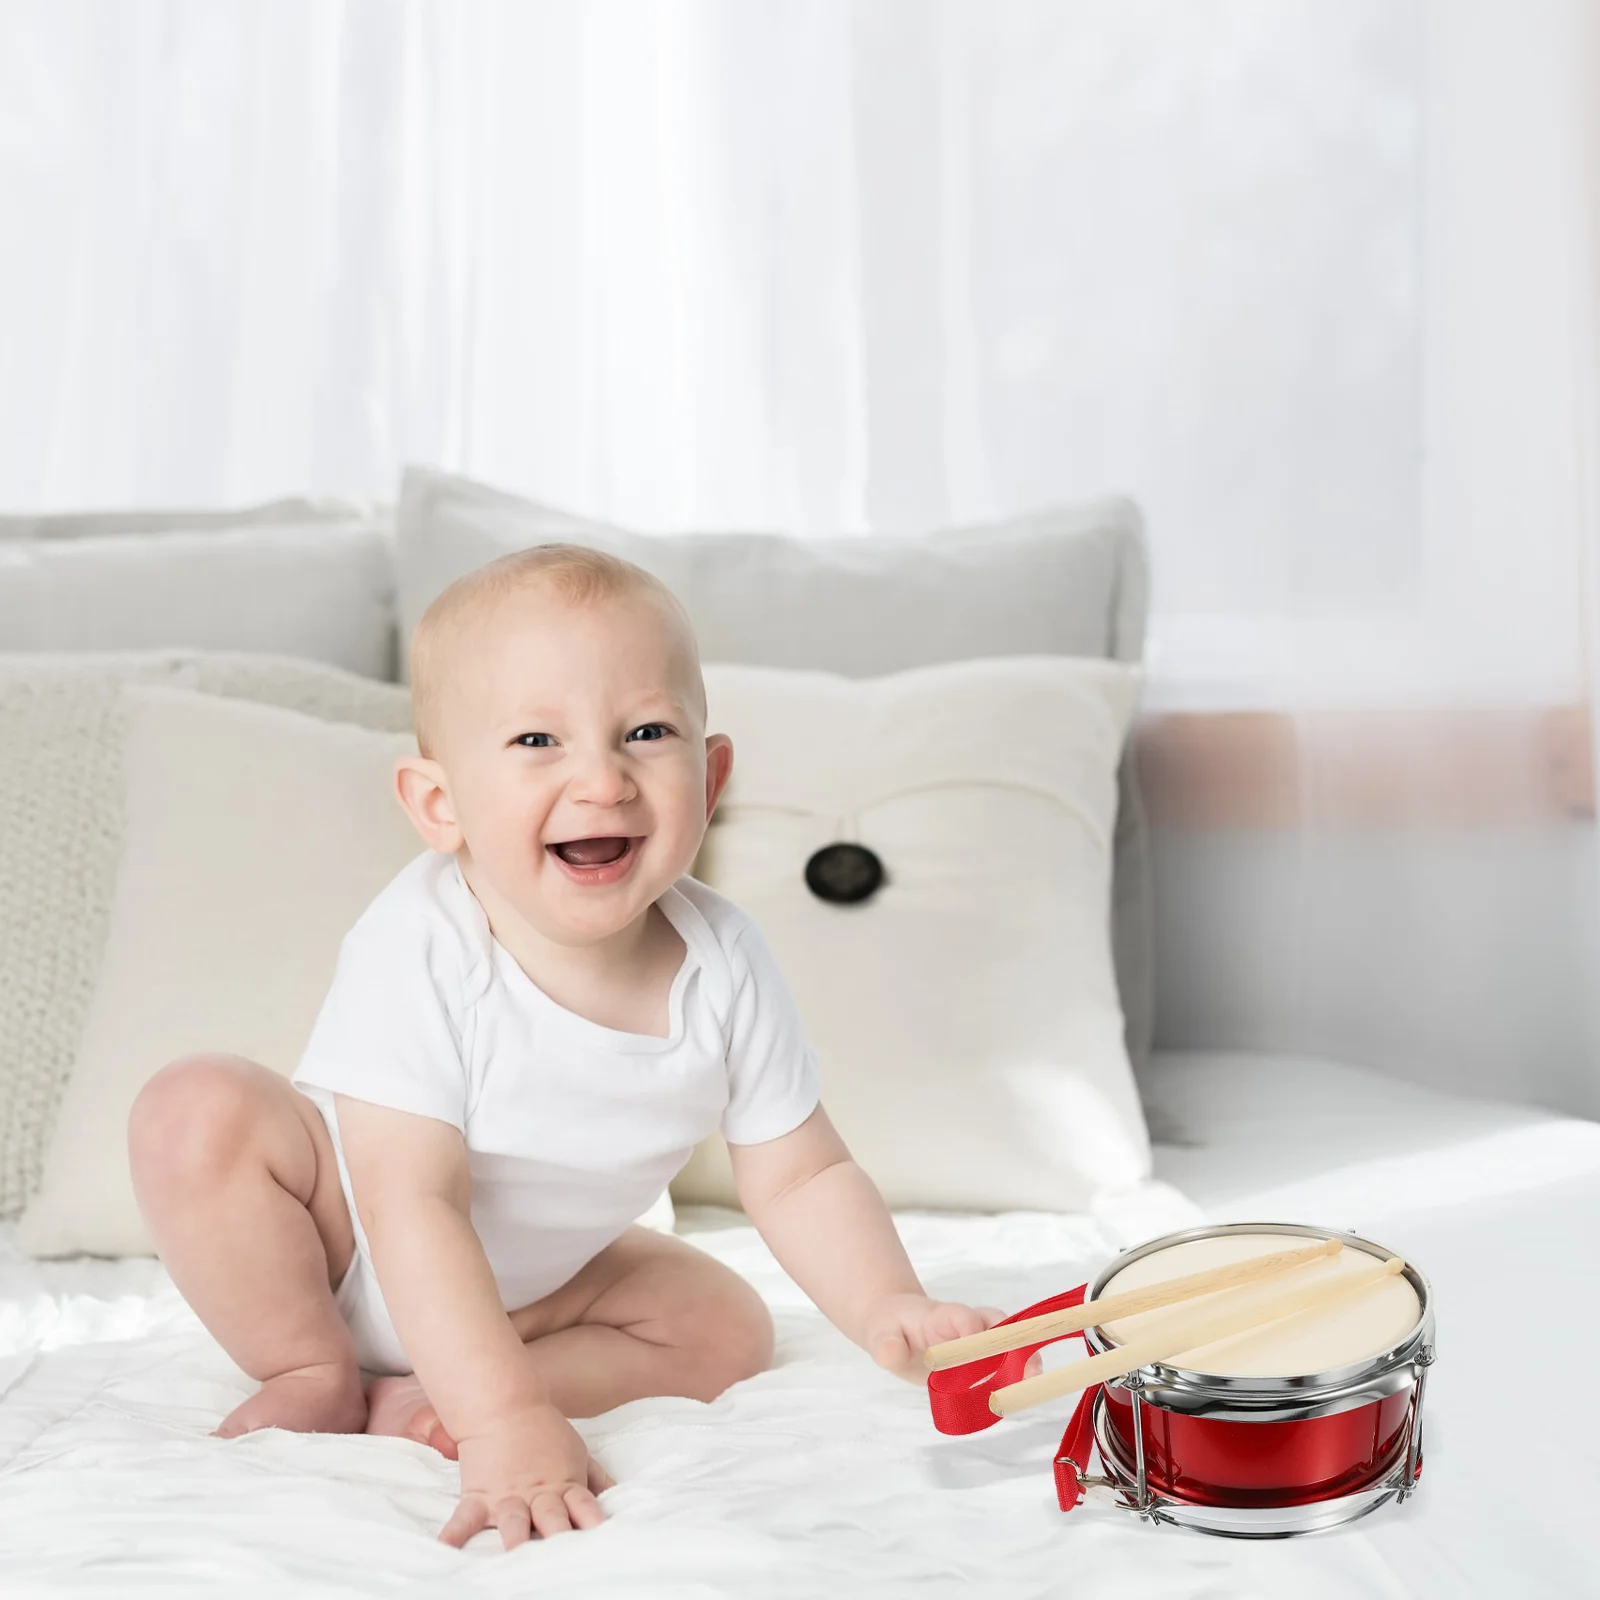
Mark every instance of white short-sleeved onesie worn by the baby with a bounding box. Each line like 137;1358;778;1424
293;851;818;1373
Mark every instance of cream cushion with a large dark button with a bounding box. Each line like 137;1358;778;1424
672;658;1150;1211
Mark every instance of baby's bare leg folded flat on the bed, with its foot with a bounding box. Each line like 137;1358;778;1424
366;1227;773;1454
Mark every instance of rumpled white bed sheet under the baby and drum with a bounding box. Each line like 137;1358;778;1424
0;1056;1600;1600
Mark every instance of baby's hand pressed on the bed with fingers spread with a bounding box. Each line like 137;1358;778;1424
440;1405;611;1550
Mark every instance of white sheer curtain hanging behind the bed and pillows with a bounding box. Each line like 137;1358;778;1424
0;0;1600;1112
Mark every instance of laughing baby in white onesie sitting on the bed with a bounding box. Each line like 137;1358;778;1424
128;544;1002;1549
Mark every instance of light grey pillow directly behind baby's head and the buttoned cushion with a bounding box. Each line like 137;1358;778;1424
395;467;1155;1081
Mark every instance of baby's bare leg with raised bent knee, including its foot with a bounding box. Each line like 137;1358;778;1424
128;1056;366;1438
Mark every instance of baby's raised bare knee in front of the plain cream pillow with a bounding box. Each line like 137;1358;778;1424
128;1056;259;1187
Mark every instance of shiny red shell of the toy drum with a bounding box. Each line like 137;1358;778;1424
1106;1384;1414;1507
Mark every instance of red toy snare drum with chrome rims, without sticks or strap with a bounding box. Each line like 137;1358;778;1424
1074;1222;1434;1538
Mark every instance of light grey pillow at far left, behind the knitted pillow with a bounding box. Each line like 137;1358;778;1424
0;501;395;678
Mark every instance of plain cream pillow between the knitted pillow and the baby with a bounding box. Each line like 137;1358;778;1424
16;685;670;1256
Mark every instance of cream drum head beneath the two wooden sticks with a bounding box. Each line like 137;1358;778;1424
1099;1232;1422;1378
